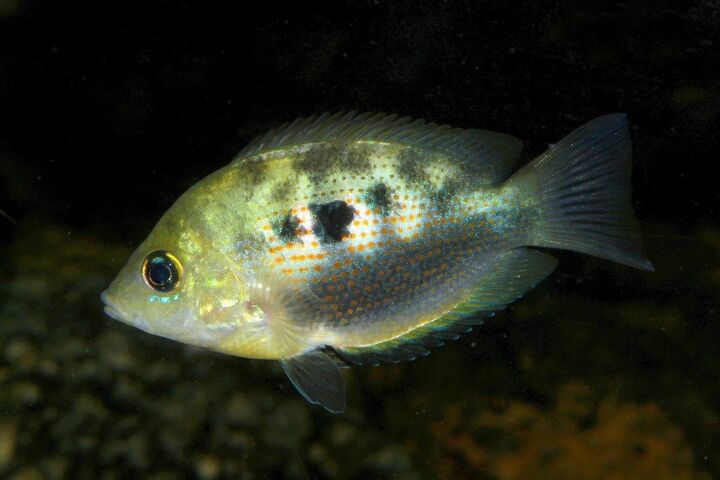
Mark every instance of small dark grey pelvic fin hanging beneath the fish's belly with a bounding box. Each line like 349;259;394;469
280;350;345;413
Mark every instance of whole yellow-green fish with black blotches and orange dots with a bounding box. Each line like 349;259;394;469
101;112;653;413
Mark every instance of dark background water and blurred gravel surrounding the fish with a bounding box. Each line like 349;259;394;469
0;0;720;480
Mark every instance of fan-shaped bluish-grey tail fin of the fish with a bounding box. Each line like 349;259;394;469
510;114;654;271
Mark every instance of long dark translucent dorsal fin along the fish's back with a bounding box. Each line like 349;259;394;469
234;112;522;184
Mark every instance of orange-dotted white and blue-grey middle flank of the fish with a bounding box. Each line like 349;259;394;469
262;183;510;324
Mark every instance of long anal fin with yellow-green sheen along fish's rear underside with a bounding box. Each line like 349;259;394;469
338;248;557;365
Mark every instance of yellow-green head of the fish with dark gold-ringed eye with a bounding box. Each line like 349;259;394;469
101;193;247;350
